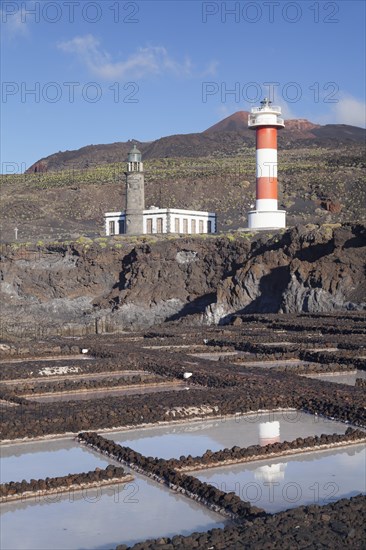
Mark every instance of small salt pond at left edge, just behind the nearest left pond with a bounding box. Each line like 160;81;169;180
0;438;109;483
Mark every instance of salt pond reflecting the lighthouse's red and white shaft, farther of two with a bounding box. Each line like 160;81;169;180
103;410;347;459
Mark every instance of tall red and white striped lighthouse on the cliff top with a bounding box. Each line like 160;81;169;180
248;98;286;229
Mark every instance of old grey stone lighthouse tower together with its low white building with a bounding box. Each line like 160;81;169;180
104;145;217;236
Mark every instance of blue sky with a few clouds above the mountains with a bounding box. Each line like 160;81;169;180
1;0;365;173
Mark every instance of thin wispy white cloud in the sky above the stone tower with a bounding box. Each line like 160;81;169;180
58;34;216;80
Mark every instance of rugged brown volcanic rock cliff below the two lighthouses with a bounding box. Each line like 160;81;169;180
1;224;366;336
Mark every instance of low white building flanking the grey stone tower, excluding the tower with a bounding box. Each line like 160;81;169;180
104;206;217;236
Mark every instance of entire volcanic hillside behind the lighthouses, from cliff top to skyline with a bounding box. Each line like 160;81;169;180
0;112;366;242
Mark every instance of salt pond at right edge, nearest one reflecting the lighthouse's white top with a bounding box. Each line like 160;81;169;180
191;444;366;513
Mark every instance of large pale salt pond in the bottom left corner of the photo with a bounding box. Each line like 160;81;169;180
0;474;225;550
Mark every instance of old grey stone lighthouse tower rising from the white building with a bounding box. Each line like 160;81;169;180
125;145;145;235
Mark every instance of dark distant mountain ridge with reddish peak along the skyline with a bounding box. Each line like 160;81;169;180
27;111;366;173
